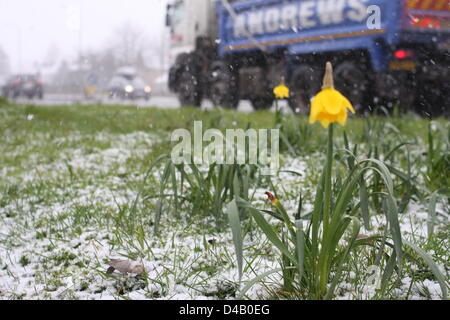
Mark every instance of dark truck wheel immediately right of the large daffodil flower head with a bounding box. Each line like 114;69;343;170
334;61;369;112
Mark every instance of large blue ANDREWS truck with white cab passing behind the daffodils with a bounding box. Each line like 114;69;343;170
167;0;450;114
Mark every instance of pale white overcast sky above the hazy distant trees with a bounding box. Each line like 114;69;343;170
0;0;166;72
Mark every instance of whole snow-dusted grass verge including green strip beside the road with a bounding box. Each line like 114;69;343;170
0;105;450;299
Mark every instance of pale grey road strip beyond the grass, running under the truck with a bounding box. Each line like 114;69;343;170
13;94;262;112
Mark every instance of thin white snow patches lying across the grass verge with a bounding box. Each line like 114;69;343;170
0;132;450;299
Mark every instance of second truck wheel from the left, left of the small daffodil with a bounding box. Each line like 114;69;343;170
210;62;239;109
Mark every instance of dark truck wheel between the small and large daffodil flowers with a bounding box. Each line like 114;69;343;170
289;64;320;114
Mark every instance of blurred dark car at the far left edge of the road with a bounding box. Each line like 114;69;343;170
2;74;44;99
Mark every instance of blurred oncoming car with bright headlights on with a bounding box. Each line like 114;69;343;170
107;67;152;100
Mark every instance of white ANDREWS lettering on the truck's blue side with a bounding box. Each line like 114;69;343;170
234;0;367;38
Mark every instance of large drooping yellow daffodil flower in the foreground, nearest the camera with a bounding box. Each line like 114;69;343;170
309;62;355;128
